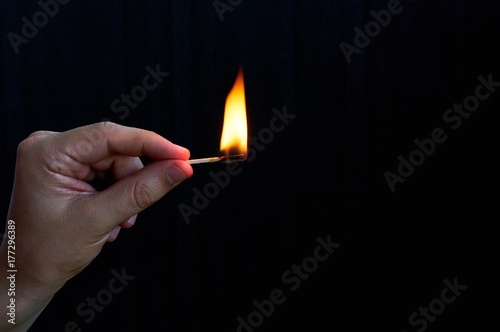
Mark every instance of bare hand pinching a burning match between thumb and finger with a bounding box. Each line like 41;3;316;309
0;122;193;332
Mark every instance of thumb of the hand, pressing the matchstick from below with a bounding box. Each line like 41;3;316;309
86;160;193;231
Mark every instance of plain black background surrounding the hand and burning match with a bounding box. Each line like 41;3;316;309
0;0;500;332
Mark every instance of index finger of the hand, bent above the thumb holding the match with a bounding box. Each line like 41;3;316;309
54;122;190;164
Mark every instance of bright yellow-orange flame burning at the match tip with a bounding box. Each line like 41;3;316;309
220;68;248;156
